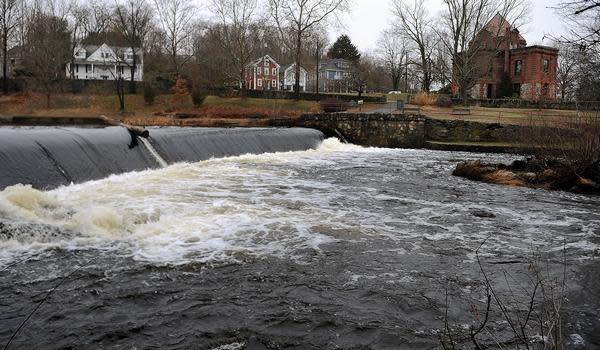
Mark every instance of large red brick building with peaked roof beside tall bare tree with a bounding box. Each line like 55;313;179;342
458;14;558;100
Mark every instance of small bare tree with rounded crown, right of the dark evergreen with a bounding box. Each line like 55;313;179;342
378;30;408;90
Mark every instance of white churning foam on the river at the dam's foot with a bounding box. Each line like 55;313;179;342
0;139;600;266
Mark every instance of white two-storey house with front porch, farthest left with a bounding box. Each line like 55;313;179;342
66;43;144;81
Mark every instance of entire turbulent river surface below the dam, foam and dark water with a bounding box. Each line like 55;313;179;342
0;139;600;349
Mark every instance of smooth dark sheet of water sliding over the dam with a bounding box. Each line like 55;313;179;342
0;127;323;190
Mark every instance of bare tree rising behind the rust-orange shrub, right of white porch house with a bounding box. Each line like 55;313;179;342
154;0;195;75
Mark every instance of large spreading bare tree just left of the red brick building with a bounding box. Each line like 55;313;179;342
438;0;529;101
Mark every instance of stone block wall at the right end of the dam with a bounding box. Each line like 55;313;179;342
297;113;426;148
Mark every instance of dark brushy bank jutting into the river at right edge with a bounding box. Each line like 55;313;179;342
452;157;600;194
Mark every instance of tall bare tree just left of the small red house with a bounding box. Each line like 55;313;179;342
212;0;257;96
